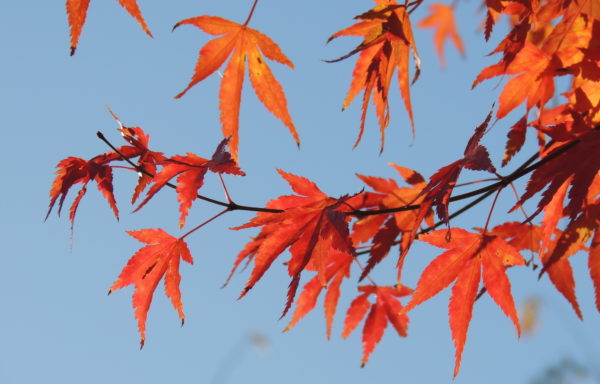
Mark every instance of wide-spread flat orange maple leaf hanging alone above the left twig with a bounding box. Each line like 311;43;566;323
173;16;300;160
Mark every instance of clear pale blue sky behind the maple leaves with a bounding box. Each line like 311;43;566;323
0;0;600;384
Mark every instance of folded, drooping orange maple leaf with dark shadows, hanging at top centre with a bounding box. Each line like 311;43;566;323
328;0;420;151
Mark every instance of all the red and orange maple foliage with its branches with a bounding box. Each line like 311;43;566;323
48;0;600;376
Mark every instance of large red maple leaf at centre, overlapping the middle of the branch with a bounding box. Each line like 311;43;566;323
233;170;355;317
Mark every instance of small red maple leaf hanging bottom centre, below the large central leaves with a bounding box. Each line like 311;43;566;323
342;285;412;366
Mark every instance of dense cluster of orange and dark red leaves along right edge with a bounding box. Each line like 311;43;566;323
473;0;600;317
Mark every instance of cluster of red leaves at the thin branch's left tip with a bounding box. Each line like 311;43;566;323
46;112;244;346
